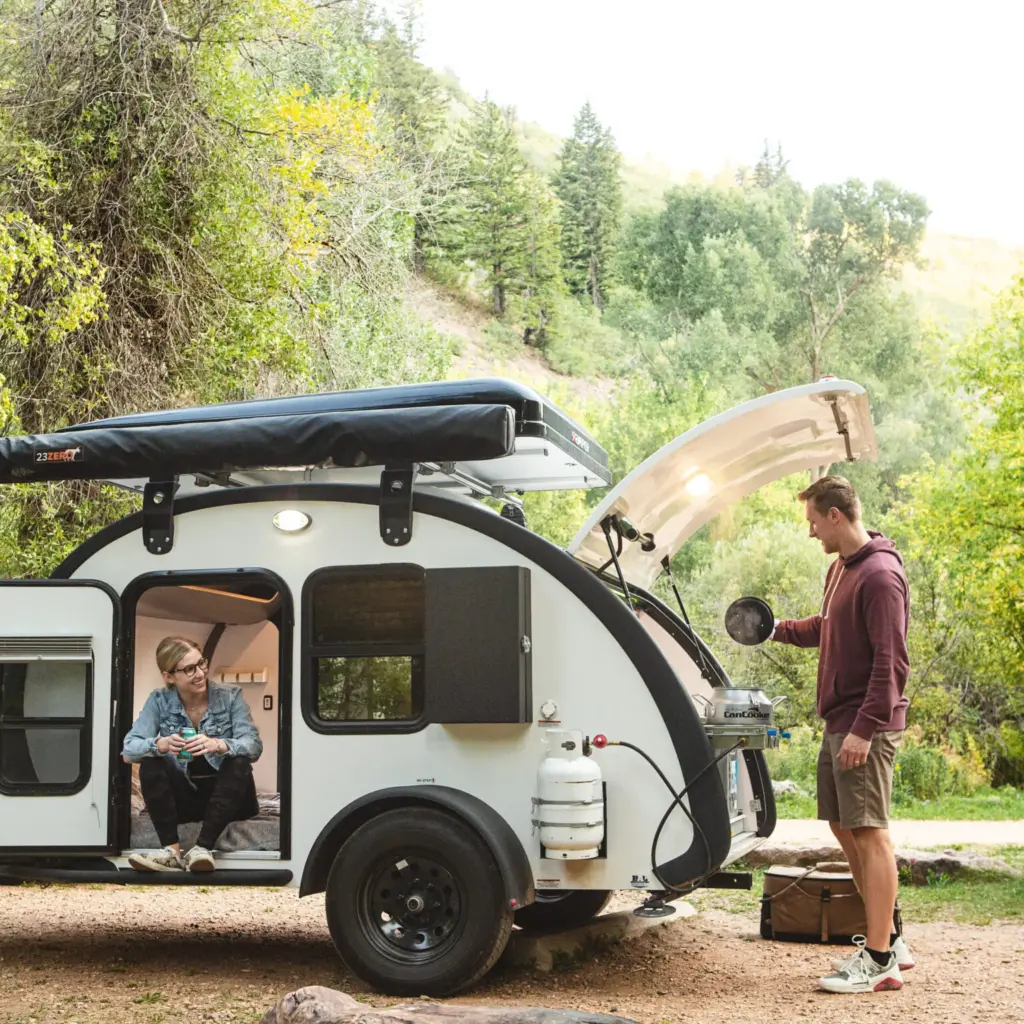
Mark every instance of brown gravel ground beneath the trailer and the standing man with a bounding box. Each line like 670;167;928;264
0;886;1024;1024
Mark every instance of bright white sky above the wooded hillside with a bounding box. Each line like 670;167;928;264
387;0;1024;245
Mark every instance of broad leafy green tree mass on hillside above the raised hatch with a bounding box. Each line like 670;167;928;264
621;157;928;391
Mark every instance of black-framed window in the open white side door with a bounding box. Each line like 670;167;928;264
0;660;91;796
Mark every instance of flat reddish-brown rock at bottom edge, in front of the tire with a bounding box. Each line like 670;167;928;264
262;985;636;1024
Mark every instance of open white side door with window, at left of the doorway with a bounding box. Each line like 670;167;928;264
0;580;118;856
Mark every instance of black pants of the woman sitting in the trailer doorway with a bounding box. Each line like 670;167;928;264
138;757;259;850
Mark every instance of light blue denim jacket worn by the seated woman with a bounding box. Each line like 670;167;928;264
122;683;263;771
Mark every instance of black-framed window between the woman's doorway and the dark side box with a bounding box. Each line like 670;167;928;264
307;565;426;724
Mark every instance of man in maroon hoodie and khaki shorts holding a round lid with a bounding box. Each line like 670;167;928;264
771;476;913;992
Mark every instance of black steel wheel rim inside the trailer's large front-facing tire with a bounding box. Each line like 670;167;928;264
364;856;462;956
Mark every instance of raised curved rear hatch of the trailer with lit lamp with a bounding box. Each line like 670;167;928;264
568;378;877;589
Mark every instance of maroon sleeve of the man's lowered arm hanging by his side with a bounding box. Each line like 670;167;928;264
850;572;910;740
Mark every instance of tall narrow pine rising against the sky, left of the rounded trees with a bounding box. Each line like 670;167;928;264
554;103;622;309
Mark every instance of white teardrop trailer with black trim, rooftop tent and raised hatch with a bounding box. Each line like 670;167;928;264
0;379;874;995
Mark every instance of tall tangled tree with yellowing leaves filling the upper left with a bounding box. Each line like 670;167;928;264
0;0;447;574
